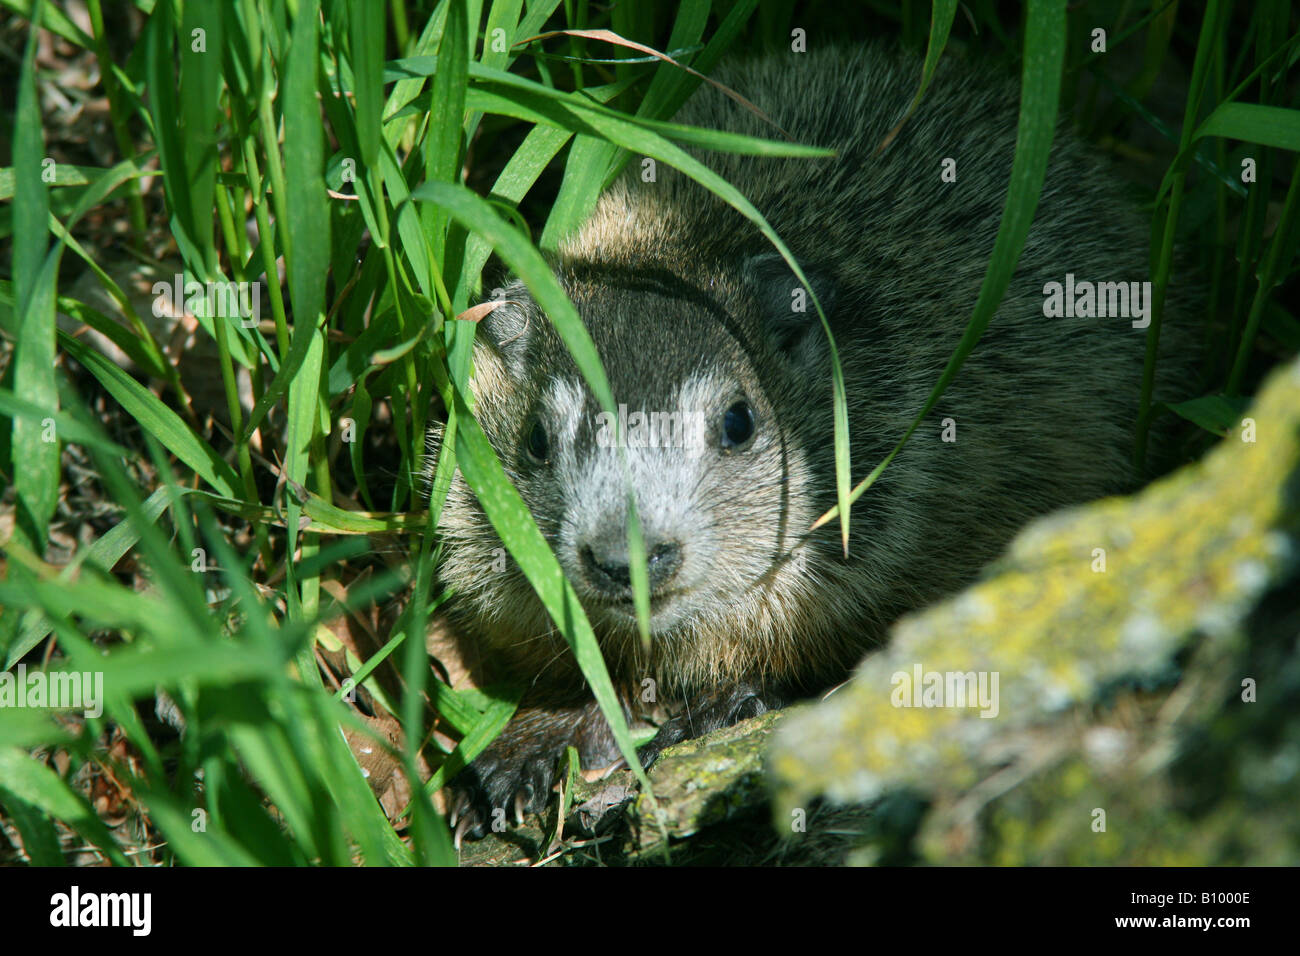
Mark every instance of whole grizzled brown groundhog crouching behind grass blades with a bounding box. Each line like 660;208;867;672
430;44;1193;844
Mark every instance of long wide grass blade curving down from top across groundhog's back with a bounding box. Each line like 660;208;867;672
813;0;1065;528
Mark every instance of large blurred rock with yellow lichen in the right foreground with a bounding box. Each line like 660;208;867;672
772;363;1300;864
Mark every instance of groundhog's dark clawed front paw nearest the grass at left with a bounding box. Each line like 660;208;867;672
447;747;560;849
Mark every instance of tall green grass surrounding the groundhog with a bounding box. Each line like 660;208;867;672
0;0;1300;865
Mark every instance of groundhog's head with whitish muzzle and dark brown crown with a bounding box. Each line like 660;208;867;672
430;254;833;681
